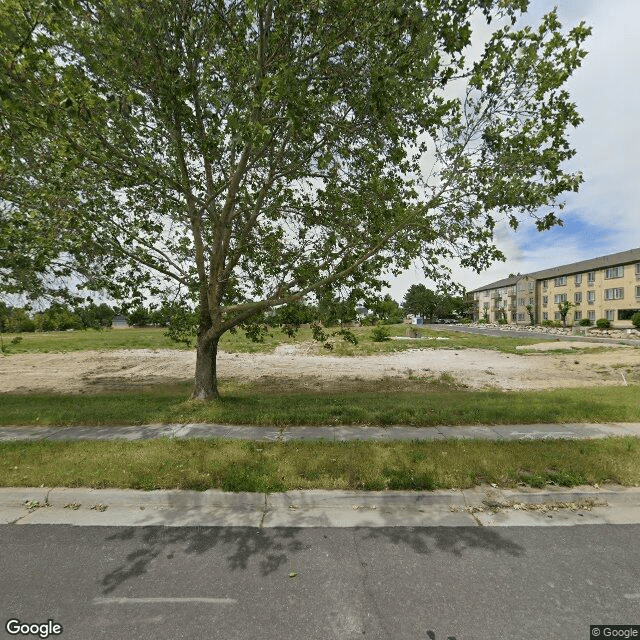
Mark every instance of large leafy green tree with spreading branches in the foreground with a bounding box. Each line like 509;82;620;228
0;0;589;398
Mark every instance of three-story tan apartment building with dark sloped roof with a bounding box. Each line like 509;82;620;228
467;248;640;328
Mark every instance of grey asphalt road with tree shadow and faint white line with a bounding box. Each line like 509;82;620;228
0;525;640;640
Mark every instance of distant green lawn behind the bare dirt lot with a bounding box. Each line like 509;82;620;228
1;324;560;355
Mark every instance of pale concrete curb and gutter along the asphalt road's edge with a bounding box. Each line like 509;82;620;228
0;485;640;528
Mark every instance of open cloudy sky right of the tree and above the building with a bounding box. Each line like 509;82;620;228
391;0;640;301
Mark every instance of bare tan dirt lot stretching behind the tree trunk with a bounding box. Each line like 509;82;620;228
0;342;640;393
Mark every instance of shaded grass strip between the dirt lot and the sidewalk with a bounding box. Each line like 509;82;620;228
0;380;640;427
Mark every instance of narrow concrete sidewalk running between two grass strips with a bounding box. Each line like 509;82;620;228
0;422;640;442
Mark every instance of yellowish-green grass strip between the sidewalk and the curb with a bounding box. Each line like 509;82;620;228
0;437;640;492
